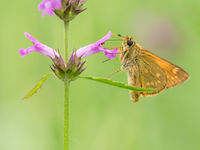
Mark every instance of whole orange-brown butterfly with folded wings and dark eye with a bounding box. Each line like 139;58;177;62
119;36;189;102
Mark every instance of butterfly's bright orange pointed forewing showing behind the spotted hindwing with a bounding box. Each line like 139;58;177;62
142;50;189;88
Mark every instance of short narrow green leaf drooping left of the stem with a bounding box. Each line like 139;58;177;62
24;73;53;99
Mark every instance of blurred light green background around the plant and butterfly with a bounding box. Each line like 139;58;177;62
0;0;200;150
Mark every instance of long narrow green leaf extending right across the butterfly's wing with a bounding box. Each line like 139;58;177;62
79;77;156;92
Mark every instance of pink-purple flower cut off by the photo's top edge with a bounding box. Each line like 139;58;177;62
38;0;62;17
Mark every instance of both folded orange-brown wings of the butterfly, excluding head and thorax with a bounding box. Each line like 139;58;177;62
129;50;189;102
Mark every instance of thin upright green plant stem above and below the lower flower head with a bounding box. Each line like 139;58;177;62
64;22;69;150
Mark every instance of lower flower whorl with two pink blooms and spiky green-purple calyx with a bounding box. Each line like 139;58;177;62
19;32;117;81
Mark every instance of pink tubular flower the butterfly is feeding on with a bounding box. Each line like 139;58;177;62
76;32;117;59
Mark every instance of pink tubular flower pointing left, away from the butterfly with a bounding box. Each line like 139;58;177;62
19;32;60;59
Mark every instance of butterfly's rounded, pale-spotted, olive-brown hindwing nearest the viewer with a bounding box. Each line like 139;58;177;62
129;52;167;102
